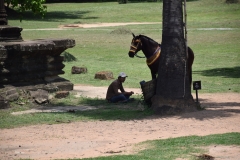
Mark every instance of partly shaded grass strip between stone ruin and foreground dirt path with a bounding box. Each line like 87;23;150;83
0;93;152;129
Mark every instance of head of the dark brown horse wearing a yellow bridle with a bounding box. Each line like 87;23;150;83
128;33;142;58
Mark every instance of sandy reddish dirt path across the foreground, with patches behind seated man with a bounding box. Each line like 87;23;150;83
0;85;240;160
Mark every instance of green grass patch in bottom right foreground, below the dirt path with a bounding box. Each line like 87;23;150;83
71;133;240;160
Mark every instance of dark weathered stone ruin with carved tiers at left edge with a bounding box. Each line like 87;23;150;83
0;1;75;108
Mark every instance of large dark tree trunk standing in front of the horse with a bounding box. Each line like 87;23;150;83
152;0;195;114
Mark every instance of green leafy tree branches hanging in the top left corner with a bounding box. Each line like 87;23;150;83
5;0;47;20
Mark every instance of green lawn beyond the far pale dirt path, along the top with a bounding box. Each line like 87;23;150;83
9;0;240;29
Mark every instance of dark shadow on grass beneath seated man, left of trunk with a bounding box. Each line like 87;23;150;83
49;98;152;121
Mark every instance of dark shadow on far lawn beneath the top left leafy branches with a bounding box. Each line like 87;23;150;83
7;11;98;22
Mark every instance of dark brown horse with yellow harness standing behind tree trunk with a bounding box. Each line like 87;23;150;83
128;34;194;84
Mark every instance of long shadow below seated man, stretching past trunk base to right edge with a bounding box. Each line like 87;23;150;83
48;96;240;121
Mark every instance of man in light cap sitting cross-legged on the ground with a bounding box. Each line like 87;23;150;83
106;72;134;103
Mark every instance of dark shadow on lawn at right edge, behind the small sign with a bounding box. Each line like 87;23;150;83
193;66;240;78
